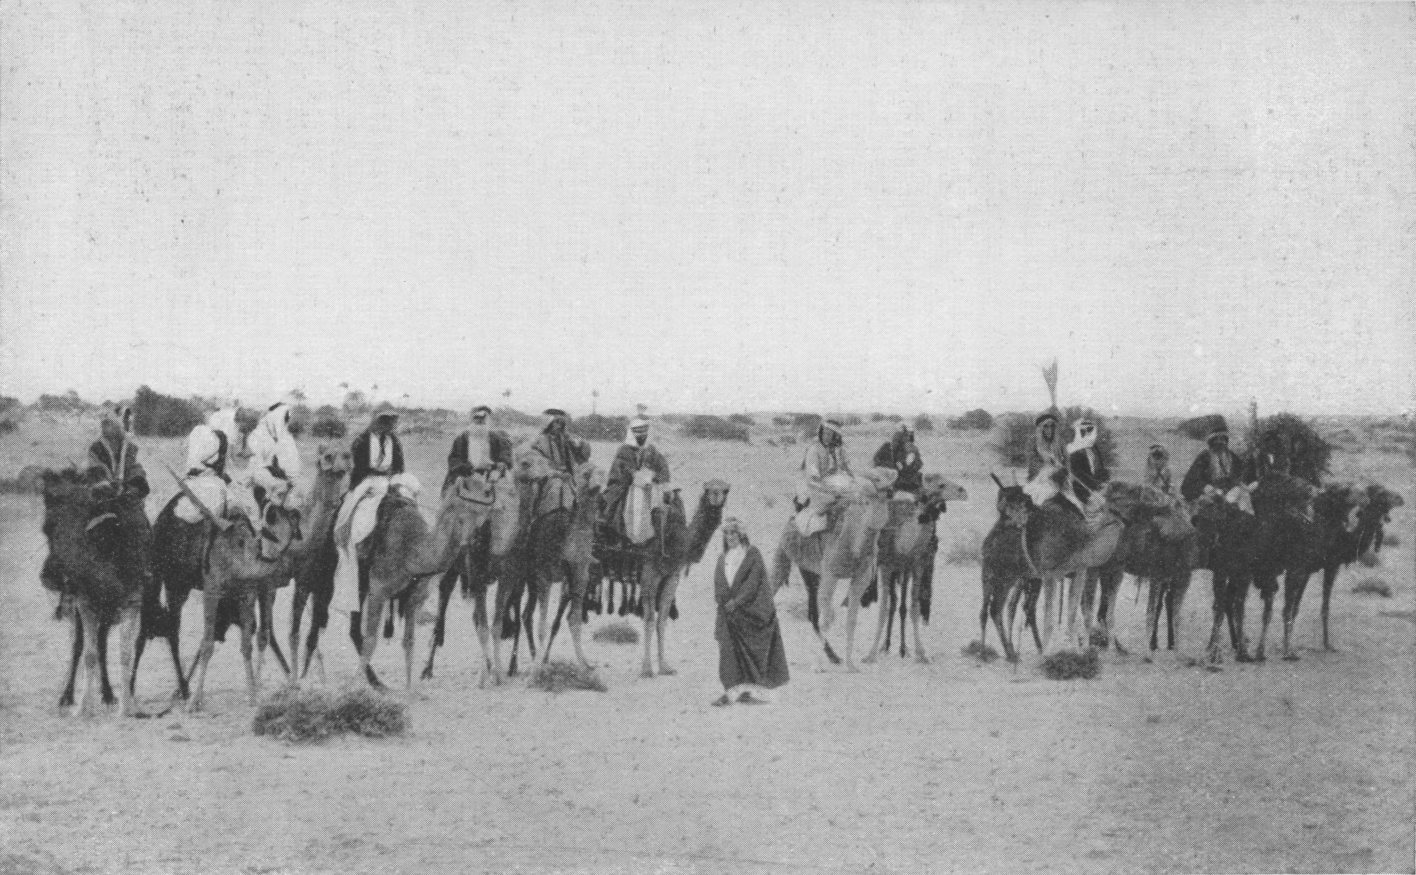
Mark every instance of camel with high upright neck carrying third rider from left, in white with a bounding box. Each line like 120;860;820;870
290;443;354;685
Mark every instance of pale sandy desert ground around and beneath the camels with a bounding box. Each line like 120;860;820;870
0;416;1416;874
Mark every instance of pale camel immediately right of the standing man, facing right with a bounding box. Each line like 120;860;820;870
772;469;895;671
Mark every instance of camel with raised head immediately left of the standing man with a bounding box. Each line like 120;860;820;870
639;480;729;678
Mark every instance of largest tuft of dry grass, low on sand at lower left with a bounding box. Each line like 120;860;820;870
251;688;408;742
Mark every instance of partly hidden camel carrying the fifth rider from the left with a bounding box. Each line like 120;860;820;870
421;467;521;687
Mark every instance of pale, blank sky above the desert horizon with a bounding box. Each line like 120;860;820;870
0;0;1416;415
